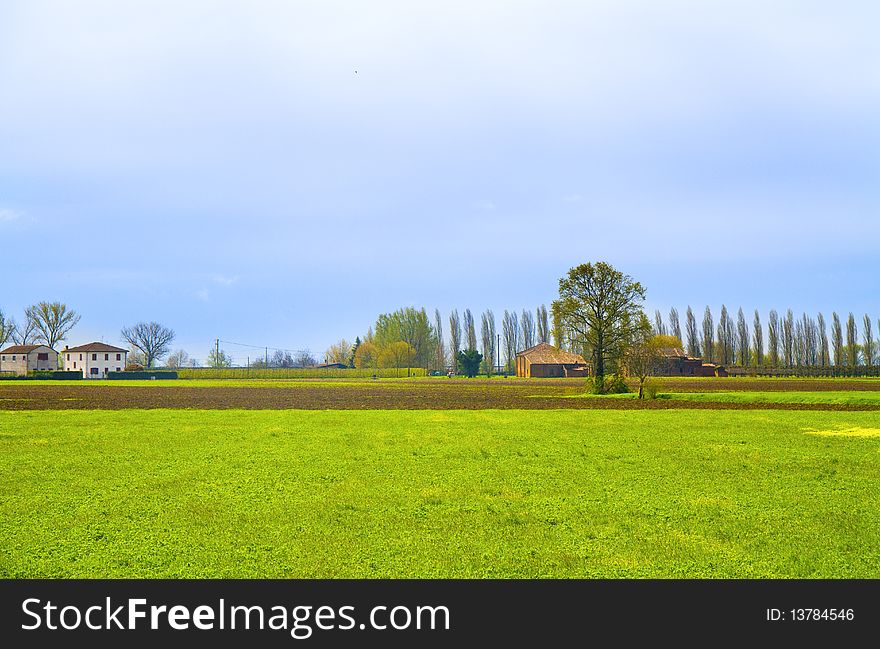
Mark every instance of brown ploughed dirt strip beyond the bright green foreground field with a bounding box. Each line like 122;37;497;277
0;379;880;411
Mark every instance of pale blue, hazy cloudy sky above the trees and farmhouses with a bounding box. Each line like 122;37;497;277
0;0;880;363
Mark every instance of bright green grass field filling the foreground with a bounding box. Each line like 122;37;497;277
0;408;880;578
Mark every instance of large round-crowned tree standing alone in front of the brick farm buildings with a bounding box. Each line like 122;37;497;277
553;261;645;392
